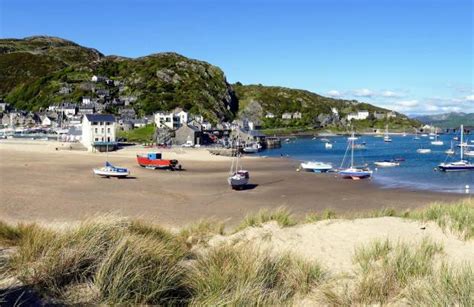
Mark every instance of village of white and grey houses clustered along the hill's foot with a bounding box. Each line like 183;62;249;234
0;75;429;155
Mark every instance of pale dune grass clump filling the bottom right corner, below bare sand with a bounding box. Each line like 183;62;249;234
321;239;474;306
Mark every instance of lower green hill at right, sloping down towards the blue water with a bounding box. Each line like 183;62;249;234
233;83;419;129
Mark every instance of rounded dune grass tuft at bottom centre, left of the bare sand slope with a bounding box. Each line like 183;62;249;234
188;245;325;306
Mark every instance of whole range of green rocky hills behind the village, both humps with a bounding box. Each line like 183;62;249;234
0;36;417;129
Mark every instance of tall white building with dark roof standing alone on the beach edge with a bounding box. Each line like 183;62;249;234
81;114;117;151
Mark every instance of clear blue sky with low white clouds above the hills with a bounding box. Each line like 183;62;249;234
0;0;474;115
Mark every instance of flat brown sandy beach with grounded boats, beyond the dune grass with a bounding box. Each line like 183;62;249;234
0;140;464;226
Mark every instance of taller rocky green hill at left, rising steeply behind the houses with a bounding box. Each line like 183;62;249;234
0;36;238;122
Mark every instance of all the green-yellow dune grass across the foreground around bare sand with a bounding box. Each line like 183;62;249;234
0;200;474;306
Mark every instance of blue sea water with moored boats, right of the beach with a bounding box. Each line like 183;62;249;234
260;135;474;194
